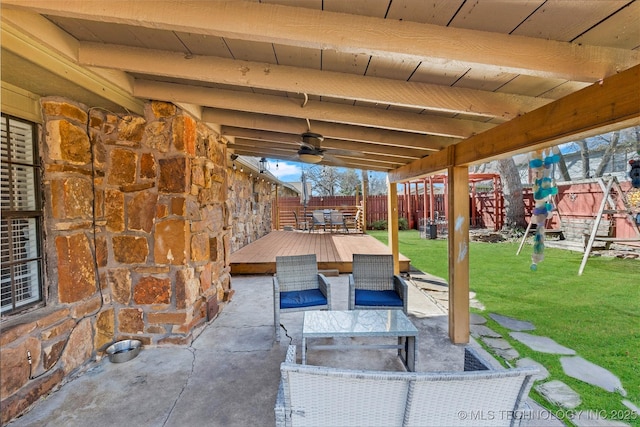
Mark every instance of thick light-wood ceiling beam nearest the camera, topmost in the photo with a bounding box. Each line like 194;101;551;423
3;0;640;82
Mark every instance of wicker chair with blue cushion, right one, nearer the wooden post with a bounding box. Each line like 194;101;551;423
349;254;408;313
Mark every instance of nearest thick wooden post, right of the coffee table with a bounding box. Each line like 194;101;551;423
447;166;469;344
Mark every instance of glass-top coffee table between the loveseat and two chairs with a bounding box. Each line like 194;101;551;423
302;310;418;371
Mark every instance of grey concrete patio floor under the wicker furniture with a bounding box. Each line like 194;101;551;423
9;275;563;427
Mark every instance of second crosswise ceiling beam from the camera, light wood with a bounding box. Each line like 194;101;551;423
78;42;552;120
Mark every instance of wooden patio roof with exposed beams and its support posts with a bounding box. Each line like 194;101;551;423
1;0;640;343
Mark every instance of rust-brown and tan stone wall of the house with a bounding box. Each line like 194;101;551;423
0;98;271;423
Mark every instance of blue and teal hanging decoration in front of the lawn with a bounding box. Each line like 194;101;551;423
529;148;560;271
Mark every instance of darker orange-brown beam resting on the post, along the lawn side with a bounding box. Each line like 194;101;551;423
389;65;640;182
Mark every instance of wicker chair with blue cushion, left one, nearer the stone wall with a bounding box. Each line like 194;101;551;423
273;254;331;341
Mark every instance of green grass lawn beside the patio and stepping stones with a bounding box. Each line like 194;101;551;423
369;230;640;426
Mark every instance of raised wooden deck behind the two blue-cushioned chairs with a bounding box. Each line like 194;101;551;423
231;231;410;275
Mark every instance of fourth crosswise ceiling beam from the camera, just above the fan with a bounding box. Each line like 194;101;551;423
210;108;460;151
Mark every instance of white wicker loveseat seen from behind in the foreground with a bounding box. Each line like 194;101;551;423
275;346;538;427
